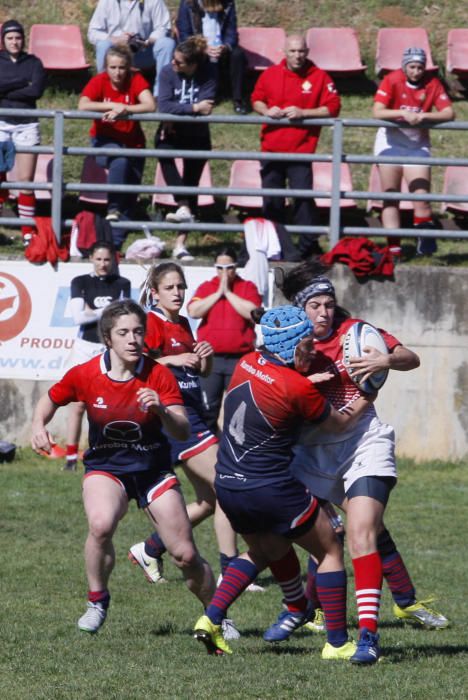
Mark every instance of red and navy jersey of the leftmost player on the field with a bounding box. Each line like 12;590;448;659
49;351;183;476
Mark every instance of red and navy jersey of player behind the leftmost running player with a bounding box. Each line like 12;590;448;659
145;309;202;412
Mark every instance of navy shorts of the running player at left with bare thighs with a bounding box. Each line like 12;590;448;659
84;469;180;508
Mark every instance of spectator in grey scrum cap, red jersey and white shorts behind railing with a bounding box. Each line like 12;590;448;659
373;47;455;255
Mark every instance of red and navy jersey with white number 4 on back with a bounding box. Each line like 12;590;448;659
216;352;330;490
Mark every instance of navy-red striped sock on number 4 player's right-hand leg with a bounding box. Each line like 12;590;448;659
316;571;348;647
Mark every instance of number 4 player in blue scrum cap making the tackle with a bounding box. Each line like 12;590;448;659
194;306;370;659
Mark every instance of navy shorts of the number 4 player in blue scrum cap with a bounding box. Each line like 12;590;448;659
216;479;319;539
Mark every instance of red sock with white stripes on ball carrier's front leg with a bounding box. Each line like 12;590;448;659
353;552;383;634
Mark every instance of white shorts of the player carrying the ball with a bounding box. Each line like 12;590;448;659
291;418;397;505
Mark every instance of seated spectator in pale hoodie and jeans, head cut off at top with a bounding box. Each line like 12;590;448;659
88;0;175;97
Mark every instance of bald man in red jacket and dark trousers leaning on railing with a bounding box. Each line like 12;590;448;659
251;34;340;258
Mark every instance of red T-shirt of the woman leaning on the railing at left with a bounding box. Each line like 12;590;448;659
81;72;150;148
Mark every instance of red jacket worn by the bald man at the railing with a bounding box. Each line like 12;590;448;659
250;59;341;153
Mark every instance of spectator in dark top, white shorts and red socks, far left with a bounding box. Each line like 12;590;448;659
0;19;46;246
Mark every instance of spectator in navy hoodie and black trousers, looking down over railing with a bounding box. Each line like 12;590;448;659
155;35;216;262
